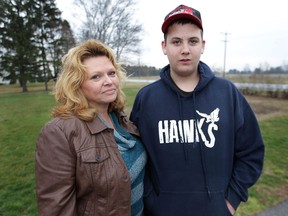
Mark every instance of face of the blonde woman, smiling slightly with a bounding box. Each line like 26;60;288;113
81;56;119;112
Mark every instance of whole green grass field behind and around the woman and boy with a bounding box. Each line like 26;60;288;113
0;83;288;216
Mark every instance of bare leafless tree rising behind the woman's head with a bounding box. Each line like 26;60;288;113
75;0;142;60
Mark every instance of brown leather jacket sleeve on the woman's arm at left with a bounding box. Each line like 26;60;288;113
35;123;77;216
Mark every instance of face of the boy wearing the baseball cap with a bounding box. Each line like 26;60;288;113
162;23;205;76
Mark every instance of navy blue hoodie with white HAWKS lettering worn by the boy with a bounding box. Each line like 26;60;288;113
130;62;264;216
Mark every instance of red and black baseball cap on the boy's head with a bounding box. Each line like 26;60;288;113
162;5;203;34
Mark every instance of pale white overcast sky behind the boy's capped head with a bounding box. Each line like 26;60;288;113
56;0;288;71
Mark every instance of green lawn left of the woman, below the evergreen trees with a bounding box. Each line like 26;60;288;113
0;92;54;216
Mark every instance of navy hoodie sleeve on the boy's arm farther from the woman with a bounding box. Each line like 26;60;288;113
226;97;264;209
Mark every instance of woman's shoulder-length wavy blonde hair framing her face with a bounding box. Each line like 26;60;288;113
51;39;126;121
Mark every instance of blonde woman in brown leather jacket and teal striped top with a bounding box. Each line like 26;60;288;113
36;40;147;216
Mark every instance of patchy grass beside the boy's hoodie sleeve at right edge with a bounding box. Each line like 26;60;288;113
237;116;288;216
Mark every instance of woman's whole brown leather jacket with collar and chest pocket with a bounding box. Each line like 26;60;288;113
36;114;139;216
